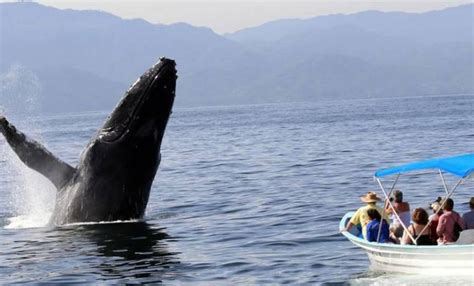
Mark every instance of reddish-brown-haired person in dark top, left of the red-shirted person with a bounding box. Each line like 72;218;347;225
400;208;436;245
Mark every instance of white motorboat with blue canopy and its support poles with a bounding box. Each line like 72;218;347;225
339;154;474;276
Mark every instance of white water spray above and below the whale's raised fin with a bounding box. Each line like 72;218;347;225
0;65;55;228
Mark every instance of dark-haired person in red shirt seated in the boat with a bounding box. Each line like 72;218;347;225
436;198;464;244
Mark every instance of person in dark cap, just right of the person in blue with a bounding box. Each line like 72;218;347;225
385;190;410;241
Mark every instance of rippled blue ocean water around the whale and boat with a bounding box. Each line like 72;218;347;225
0;95;474;285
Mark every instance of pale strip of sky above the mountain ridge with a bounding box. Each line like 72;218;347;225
4;0;472;34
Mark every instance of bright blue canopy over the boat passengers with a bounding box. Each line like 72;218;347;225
375;154;474;178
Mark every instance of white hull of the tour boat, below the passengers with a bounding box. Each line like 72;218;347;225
340;212;474;276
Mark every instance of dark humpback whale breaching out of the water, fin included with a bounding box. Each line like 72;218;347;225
0;58;177;225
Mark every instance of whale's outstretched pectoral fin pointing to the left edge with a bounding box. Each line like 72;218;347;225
0;116;76;189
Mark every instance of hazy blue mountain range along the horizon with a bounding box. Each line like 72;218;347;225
0;3;474;113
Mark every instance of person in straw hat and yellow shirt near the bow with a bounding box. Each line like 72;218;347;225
343;192;390;239
